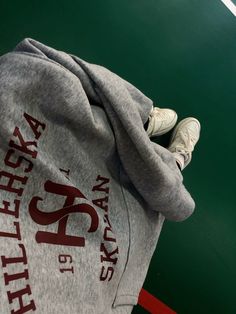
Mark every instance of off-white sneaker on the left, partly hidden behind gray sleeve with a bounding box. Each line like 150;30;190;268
147;107;178;137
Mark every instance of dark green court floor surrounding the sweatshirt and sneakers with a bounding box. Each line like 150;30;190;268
0;0;236;314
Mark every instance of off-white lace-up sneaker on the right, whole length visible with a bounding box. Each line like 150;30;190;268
168;117;201;170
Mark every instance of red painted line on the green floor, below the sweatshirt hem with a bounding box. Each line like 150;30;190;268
138;289;177;314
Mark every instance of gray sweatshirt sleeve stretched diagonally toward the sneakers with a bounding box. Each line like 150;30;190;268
66;57;195;221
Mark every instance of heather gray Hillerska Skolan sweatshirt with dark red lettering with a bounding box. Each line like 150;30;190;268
0;38;195;314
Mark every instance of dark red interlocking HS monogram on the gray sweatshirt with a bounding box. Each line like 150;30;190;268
29;180;99;247
